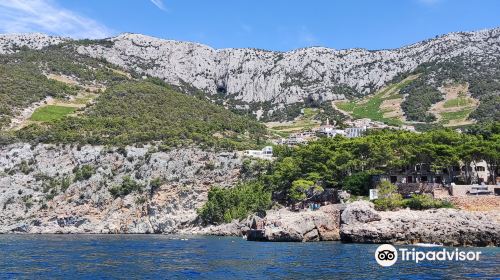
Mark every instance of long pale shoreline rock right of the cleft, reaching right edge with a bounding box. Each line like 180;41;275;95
340;203;500;246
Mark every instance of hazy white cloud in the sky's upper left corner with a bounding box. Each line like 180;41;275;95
0;0;113;39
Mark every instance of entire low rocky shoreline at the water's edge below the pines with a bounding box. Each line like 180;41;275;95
195;201;500;247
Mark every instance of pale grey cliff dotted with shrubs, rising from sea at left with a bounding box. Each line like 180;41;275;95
0;144;241;233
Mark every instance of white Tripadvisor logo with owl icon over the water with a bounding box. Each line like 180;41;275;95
375;244;481;266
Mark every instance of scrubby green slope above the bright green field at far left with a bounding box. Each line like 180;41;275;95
0;44;131;128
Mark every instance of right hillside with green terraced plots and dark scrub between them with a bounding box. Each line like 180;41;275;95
334;55;500;129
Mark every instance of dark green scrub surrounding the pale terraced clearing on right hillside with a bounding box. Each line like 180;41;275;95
394;57;500;123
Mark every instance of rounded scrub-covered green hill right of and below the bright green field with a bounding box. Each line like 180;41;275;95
13;81;265;149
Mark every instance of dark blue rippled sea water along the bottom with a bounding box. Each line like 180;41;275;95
0;235;500;280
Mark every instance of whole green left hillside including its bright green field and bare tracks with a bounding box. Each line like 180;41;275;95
0;43;265;149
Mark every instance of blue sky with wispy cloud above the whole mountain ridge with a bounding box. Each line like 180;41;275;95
0;0;500;51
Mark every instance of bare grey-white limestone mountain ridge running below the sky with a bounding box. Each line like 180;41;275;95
0;28;500;121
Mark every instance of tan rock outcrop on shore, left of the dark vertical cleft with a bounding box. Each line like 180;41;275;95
247;205;340;242
